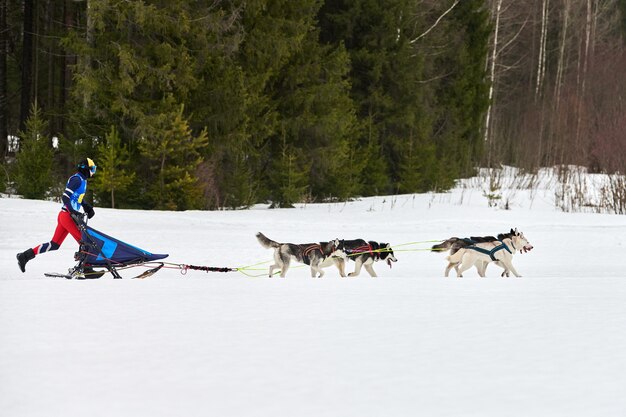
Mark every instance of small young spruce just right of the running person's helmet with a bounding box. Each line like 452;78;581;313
93;126;135;208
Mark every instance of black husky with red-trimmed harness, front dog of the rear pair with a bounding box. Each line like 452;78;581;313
334;239;398;277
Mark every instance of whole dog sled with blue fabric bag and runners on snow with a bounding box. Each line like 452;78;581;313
45;216;168;279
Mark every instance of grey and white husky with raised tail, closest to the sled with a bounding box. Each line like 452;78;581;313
256;232;345;278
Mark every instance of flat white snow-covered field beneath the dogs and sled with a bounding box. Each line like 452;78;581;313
0;180;626;417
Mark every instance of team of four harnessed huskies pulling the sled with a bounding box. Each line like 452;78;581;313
256;229;533;278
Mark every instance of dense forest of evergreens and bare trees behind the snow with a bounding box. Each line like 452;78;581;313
0;0;626;210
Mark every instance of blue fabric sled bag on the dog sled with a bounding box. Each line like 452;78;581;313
82;226;169;266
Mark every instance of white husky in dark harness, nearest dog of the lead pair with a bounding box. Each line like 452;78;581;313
446;229;533;278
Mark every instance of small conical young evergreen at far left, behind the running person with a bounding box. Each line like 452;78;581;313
15;101;54;199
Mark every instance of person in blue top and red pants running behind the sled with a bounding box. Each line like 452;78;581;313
17;158;97;272
